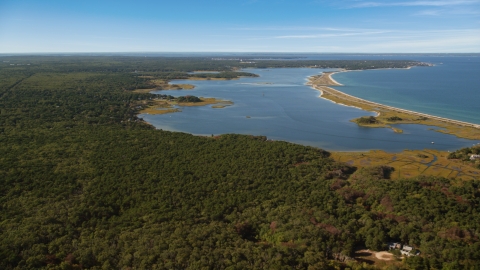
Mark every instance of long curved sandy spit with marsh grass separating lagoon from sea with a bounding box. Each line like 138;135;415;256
307;70;480;140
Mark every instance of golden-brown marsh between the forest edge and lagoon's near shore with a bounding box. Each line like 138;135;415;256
332;149;480;180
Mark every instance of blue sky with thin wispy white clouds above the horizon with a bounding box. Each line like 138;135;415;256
0;0;480;53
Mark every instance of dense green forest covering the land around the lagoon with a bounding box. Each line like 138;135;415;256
0;56;480;269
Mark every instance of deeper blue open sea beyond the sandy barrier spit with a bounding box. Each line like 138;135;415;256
333;56;480;124
